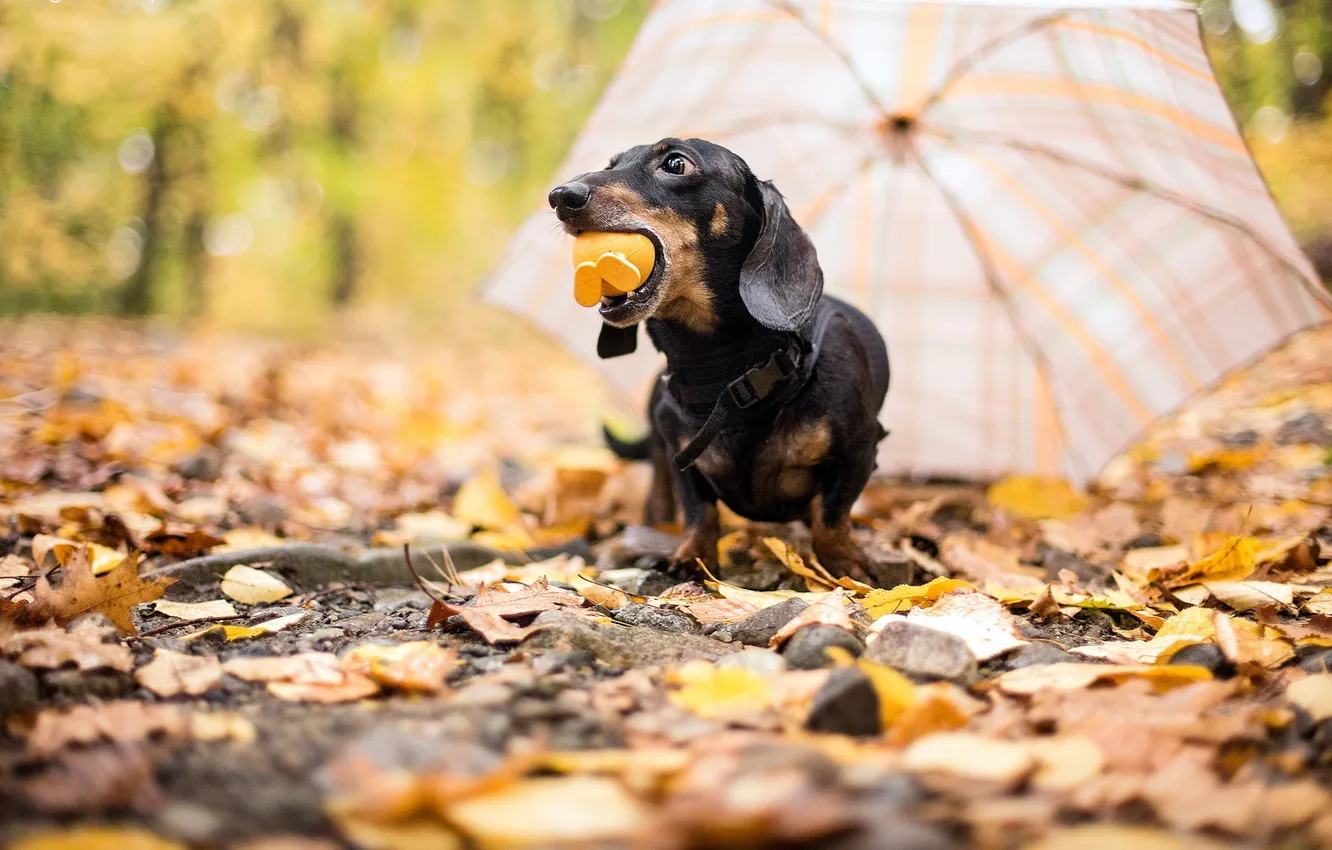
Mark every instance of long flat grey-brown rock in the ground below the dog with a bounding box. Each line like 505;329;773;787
522;612;735;667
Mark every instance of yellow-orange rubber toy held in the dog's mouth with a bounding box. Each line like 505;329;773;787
573;230;661;324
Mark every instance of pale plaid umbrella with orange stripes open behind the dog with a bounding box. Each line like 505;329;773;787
485;0;1332;481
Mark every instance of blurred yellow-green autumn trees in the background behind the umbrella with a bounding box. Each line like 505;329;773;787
0;0;1332;340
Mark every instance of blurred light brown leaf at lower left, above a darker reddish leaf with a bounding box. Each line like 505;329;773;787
28;699;189;758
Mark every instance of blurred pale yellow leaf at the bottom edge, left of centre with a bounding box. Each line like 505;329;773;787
442;775;646;847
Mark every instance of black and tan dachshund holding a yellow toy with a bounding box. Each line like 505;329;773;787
550;139;888;578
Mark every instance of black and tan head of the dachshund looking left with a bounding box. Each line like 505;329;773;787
550;139;823;333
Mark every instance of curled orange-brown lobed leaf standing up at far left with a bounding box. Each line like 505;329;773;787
27;546;177;634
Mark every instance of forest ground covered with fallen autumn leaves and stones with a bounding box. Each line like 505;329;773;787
0;320;1332;849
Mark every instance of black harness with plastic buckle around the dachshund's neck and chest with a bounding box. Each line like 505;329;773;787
662;303;835;470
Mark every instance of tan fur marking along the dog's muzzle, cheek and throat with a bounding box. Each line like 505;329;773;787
598;187;719;333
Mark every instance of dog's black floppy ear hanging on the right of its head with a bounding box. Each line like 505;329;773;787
741;183;823;330
